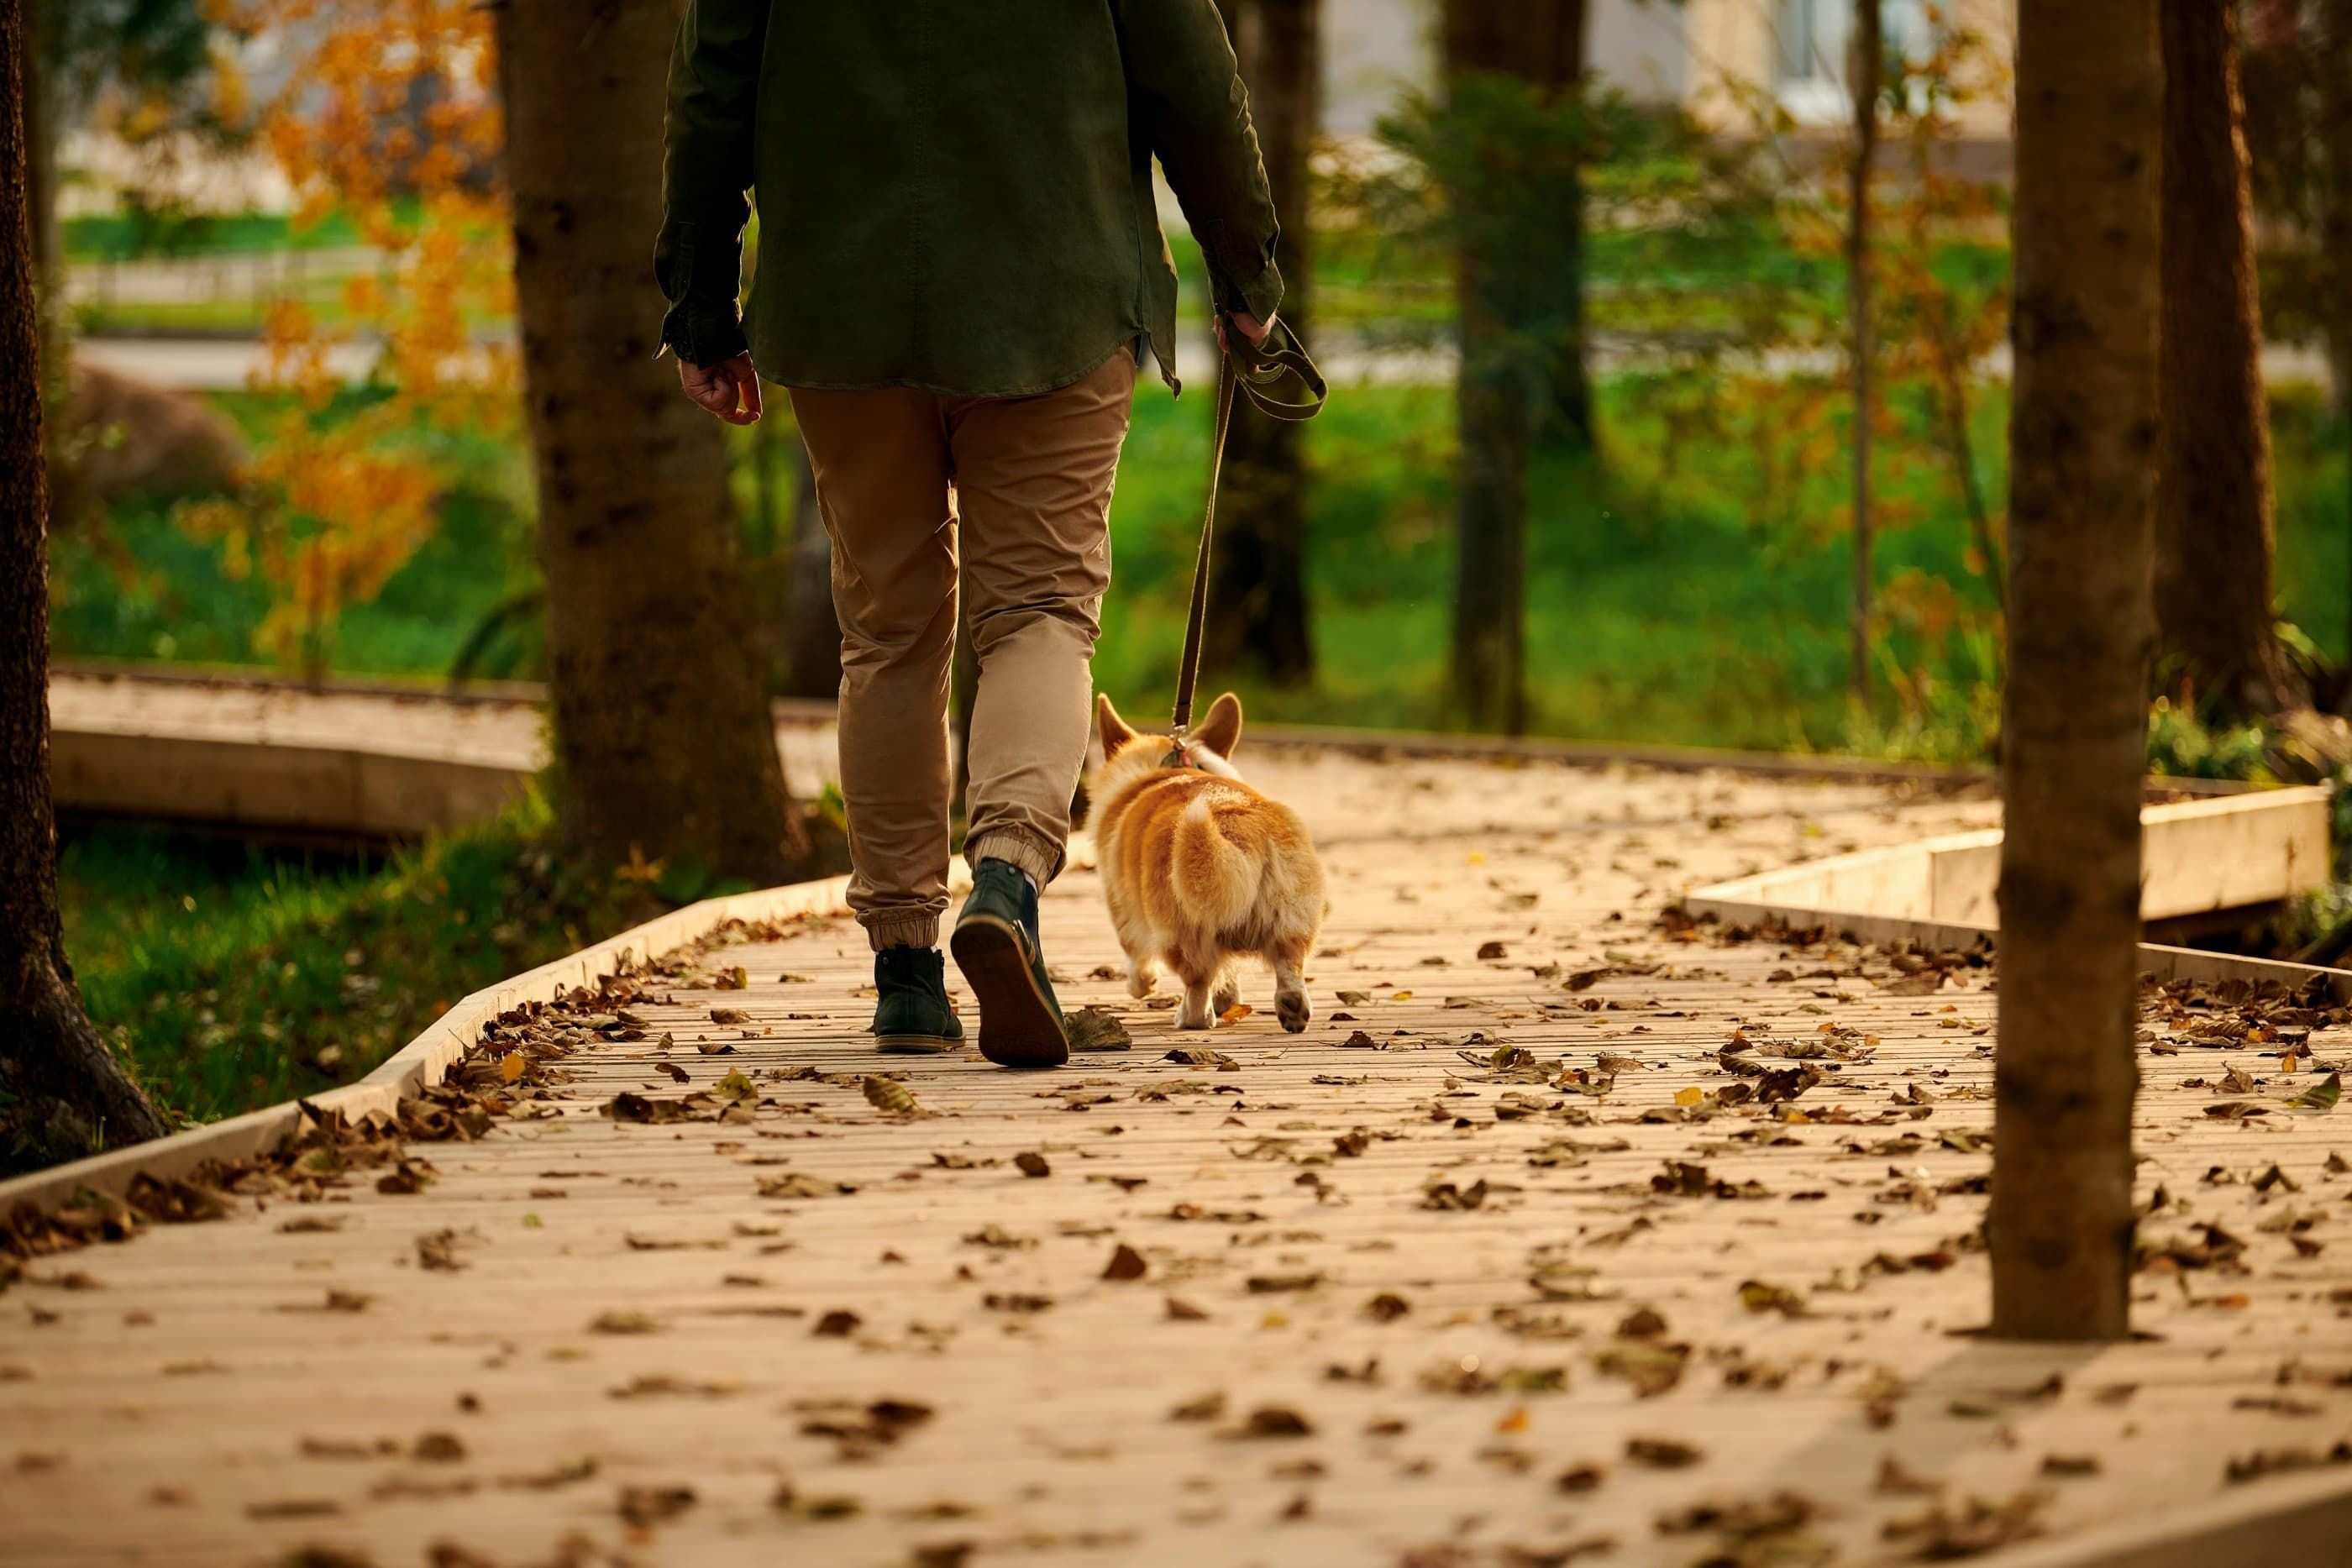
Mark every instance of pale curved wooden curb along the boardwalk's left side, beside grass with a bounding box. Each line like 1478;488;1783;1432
0;877;849;1213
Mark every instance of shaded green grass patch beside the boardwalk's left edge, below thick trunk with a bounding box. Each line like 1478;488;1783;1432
59;806;628;1121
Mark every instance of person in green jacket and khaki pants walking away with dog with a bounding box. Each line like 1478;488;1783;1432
654;0;1282;1067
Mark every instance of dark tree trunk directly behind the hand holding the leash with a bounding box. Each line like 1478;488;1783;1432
1202;0;1322;686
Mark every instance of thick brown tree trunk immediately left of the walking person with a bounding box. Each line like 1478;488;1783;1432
499;0;806;882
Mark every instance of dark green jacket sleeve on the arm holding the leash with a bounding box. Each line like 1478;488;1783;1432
1115;0;1282;322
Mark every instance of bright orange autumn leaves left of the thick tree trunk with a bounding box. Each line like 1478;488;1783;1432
183;0;515;679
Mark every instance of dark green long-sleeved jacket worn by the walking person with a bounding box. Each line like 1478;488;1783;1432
654;0;1282;397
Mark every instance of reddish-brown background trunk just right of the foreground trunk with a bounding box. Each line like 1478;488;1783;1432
2155;0;2307;715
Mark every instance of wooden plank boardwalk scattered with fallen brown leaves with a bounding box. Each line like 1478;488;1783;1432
0;745;2352;1568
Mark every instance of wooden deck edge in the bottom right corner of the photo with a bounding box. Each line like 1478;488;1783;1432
1982;1469;2352;1568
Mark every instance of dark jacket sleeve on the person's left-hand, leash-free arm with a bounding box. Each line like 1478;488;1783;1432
654;0;769;364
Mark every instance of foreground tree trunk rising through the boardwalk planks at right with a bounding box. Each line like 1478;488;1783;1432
1987;0;2164;1340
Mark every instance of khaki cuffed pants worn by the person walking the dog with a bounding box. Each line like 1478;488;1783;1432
793;348;1136;950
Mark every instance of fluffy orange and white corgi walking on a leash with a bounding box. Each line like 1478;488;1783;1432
1091;691;1324;1035
